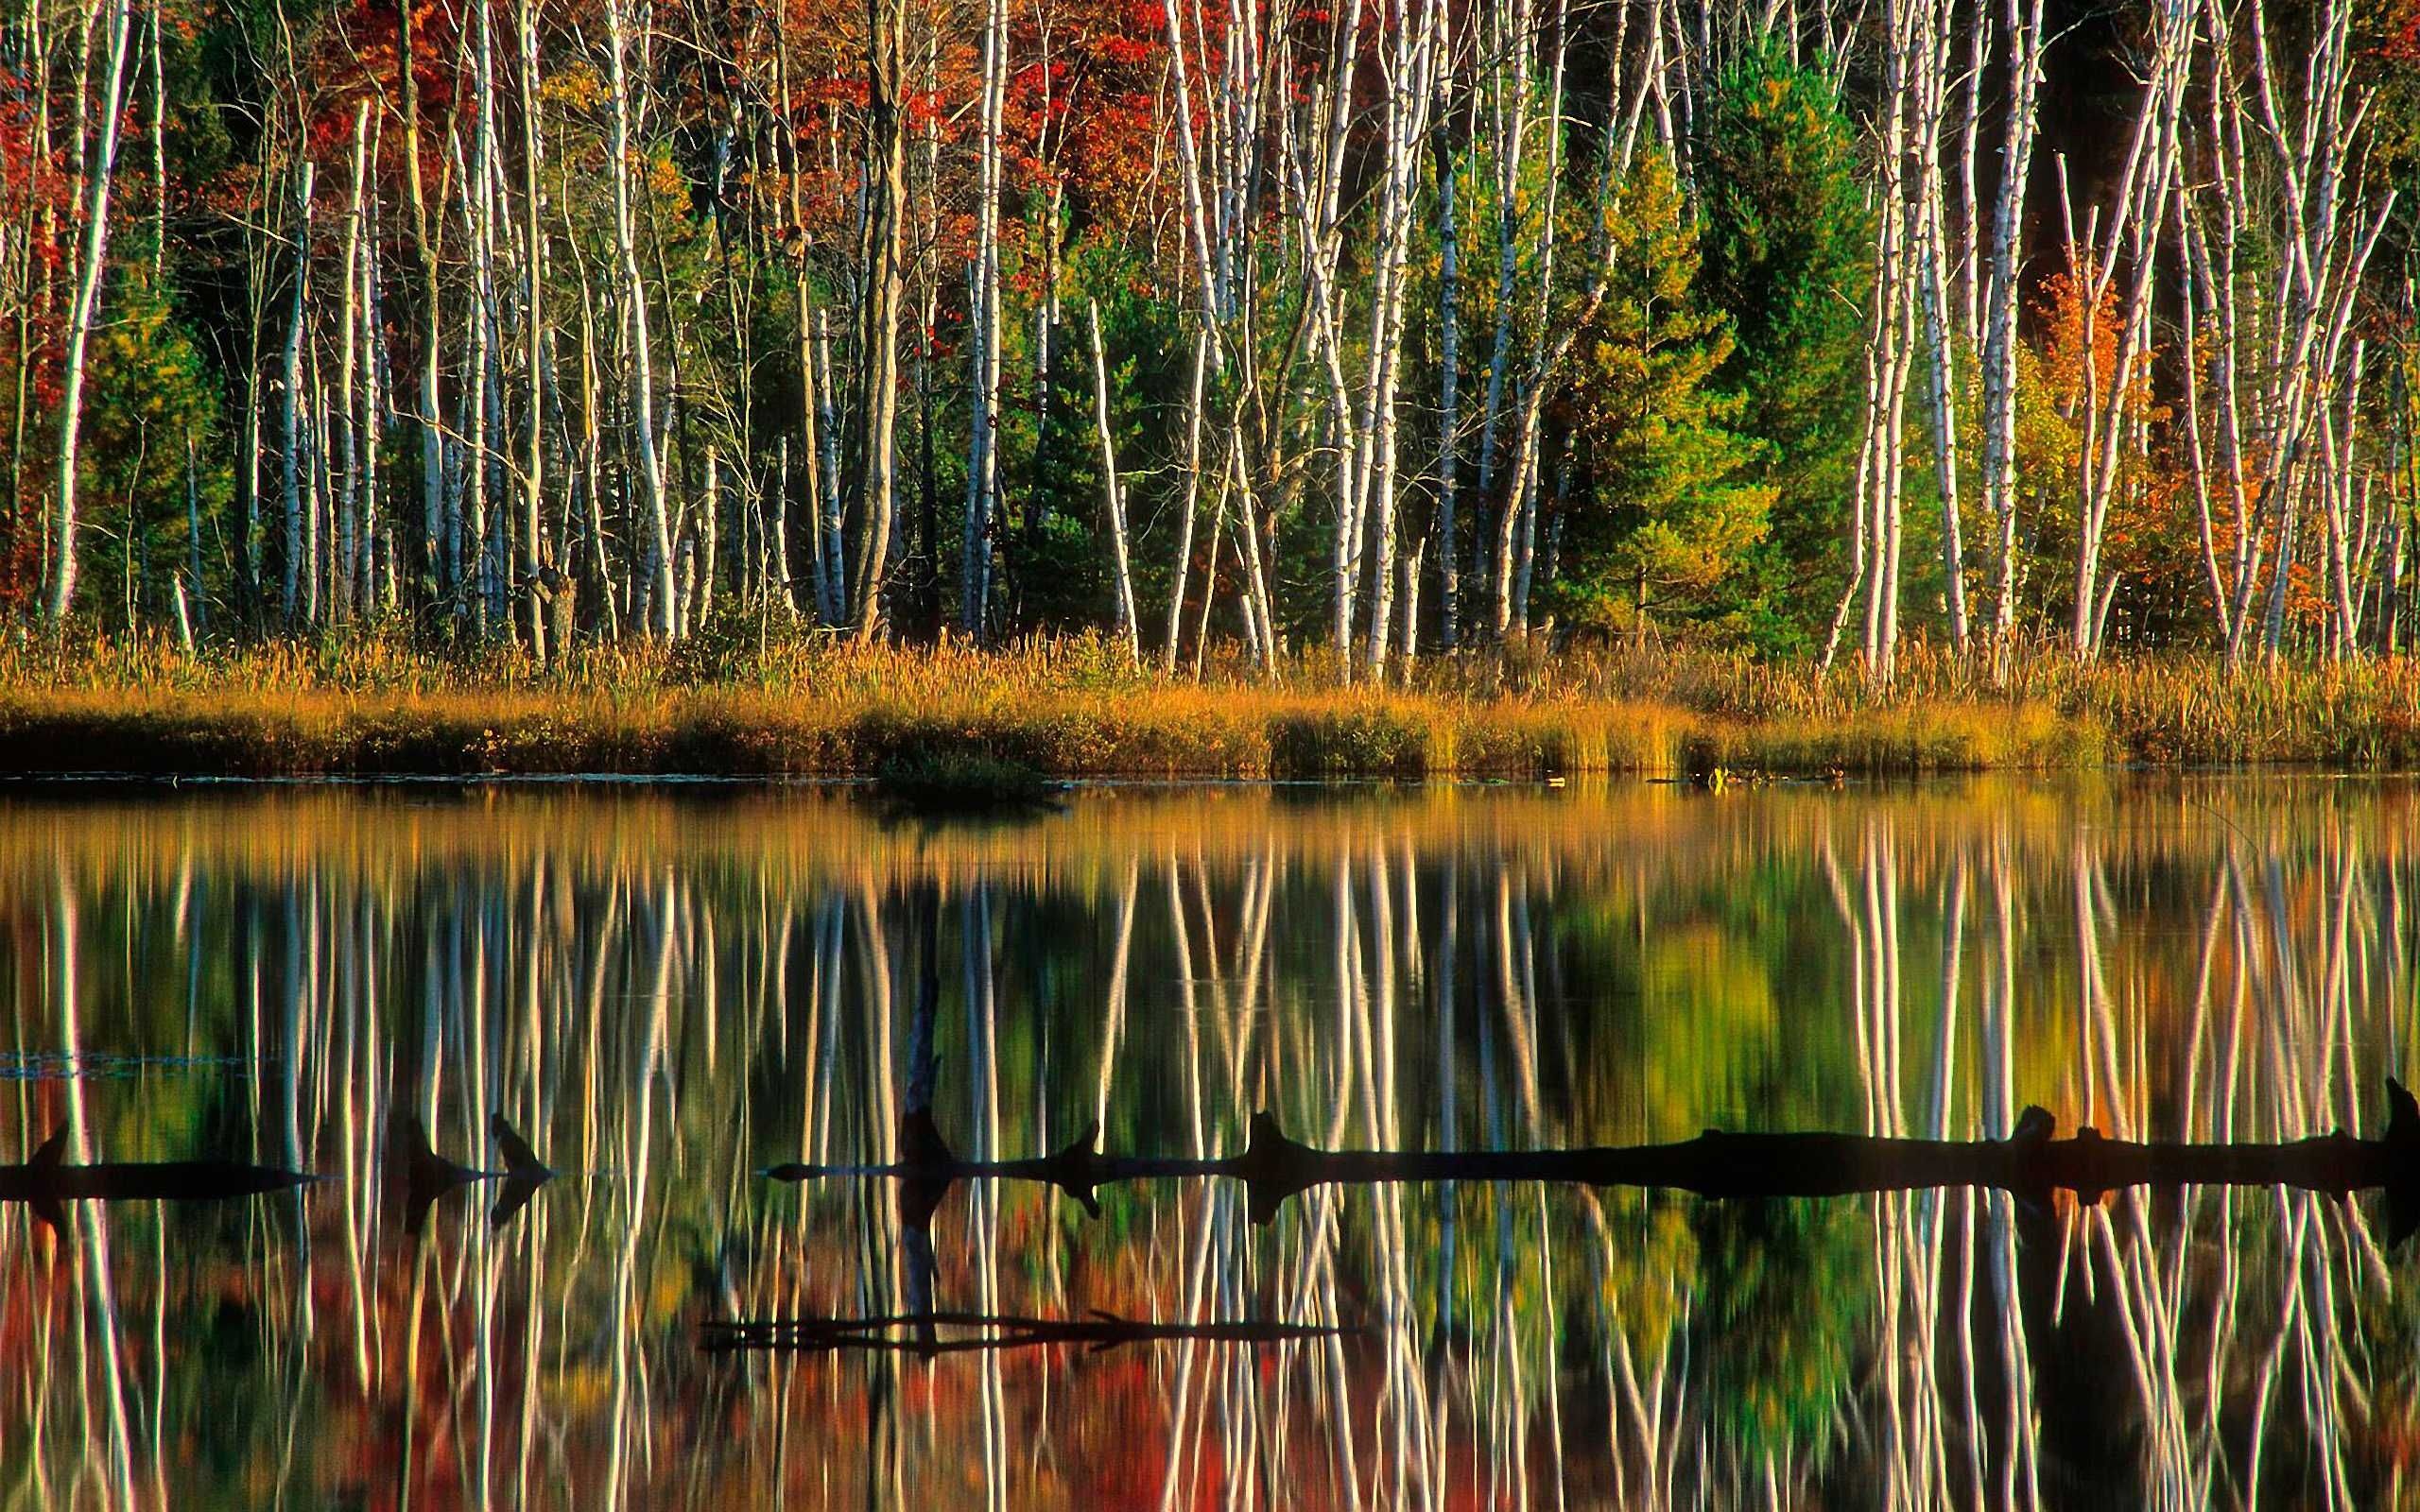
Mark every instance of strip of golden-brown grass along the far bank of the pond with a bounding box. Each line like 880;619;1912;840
0;636;2420;779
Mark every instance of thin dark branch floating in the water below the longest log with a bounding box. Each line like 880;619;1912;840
701;1312;1353;1357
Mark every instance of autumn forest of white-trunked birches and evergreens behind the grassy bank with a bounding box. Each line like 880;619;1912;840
0;0;2420;679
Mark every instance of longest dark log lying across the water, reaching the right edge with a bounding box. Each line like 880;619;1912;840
768;1079;2420;1244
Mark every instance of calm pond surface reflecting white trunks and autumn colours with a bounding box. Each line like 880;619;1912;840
0;779;2420;1509
